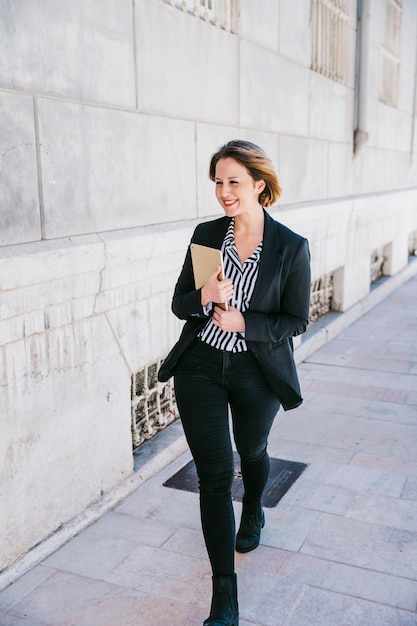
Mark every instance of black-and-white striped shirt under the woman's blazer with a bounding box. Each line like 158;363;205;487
199;219;262;352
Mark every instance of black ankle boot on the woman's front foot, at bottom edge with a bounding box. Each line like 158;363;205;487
203;574;239;626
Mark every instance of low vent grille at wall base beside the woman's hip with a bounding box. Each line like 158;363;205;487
131;361;178;450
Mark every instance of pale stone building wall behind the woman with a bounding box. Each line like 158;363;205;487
0;0;417;570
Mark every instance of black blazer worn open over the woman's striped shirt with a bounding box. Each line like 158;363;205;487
158;211;311;410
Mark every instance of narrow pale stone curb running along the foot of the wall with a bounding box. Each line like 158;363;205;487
0;259;417;591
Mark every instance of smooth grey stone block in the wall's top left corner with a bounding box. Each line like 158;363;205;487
0;0;135;107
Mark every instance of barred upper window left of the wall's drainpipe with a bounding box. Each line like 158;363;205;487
311;0;349;83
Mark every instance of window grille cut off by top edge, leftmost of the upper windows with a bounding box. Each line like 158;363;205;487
165;0;238;33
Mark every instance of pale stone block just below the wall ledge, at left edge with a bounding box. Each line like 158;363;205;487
0;235;105;345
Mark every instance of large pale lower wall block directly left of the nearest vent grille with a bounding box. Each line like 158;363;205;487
0;317;133;567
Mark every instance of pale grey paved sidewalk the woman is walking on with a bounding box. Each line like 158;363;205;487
0;262;417;626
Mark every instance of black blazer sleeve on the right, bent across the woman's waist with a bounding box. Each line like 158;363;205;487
243;238;311;344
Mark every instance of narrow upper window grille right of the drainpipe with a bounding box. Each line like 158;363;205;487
380;0;402;107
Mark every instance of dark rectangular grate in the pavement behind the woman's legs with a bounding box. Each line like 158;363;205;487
164;452;307;508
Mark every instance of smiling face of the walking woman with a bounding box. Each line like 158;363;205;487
214;157;265;217
